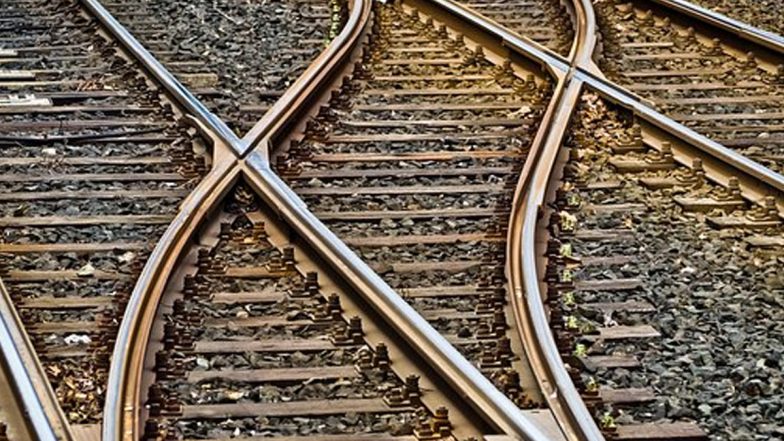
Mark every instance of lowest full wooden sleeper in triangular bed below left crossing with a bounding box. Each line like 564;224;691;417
180;398;404;420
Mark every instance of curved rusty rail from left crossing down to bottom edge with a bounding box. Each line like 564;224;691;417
102;155;239;441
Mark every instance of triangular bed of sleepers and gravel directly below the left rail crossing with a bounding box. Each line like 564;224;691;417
133;182;502;440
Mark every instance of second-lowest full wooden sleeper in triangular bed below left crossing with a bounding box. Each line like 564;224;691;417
187;366;359;383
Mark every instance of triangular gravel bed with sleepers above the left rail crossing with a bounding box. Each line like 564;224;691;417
98;0;346;135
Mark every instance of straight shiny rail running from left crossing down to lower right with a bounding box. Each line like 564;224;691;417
243;153;547;441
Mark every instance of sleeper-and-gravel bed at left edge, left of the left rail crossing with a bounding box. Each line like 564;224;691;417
0;1;209;431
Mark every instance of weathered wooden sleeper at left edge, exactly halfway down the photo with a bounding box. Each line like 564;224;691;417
0;214;174;227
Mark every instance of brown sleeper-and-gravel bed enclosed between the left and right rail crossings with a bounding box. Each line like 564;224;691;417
277;0;550;416
